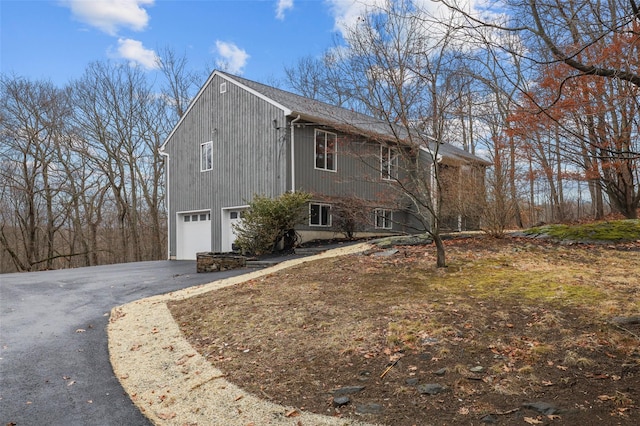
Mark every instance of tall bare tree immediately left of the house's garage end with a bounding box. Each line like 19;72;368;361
74;63;170;262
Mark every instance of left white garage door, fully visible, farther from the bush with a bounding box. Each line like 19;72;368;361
176;211;211;260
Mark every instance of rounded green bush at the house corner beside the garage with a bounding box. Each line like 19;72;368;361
234;192;311;255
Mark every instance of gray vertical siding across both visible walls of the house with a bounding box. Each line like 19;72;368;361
165;74;436;256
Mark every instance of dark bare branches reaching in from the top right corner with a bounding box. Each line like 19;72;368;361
442;0;640;86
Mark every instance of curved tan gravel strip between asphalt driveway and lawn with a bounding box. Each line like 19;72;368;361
107;243;371;426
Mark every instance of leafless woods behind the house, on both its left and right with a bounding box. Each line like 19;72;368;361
0;0;640;272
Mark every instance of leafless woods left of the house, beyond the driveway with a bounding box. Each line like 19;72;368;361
0;51;196;272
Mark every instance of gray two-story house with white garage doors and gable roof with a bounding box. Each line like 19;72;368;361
160;71;487;259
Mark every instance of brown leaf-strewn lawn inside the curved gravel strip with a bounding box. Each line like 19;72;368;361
166;240;637;425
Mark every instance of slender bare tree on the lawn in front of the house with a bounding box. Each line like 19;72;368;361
322;1;482;267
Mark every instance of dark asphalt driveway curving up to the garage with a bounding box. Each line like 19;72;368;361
0;261;248;426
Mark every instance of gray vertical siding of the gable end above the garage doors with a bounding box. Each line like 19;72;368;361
166;76;287;255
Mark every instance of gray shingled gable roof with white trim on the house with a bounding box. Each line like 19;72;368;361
161;70;491;166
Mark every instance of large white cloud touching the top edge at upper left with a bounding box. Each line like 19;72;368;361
62;0;155;35
